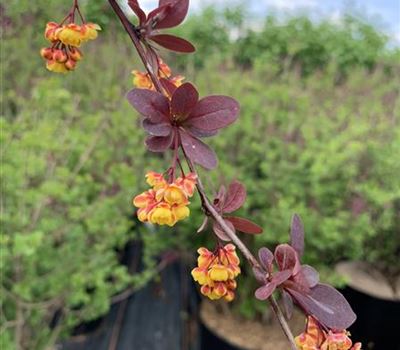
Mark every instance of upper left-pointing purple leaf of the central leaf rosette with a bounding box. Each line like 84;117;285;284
127;89;169;123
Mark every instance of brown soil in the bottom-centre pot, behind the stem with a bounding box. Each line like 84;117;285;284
200;301;305;350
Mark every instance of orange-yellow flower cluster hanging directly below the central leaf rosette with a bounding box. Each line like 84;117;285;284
133;171;197;226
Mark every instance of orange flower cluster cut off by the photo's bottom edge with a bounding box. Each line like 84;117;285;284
295;316;361;350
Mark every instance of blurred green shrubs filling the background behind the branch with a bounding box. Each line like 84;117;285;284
0;0;400;349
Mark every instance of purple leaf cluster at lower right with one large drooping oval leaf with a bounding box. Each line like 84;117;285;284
254;215;356;330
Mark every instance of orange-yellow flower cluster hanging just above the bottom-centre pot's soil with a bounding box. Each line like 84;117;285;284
192;243;240;301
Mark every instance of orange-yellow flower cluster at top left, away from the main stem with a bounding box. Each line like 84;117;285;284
40;22;100;73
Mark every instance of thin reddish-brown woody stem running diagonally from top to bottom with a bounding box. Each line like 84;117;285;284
108;0;297;350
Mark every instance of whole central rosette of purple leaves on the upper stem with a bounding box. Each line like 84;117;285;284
127;83;239;169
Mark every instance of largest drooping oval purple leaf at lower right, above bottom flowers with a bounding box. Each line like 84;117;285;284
288;283;356;330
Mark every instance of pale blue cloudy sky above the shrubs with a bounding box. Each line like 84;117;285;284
135;0;400;46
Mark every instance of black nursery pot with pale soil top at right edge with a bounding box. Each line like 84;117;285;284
336;261;400;350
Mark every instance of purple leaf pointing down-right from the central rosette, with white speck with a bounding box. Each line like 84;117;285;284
179;129;217;169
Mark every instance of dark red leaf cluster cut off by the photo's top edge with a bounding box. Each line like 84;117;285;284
128;0;195;52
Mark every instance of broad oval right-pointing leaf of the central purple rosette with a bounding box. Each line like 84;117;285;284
187;96;240;130
